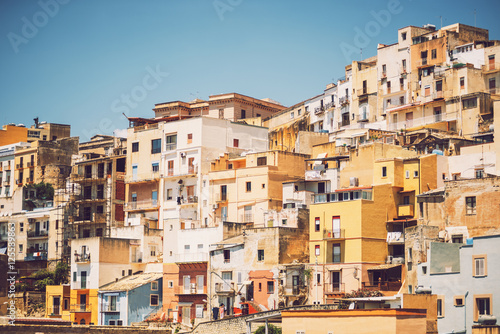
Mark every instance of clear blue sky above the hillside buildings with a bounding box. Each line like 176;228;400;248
0;0;500;141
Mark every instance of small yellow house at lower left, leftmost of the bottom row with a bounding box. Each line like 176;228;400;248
45;285;71;321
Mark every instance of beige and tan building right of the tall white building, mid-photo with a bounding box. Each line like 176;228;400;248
209;151;309;226
